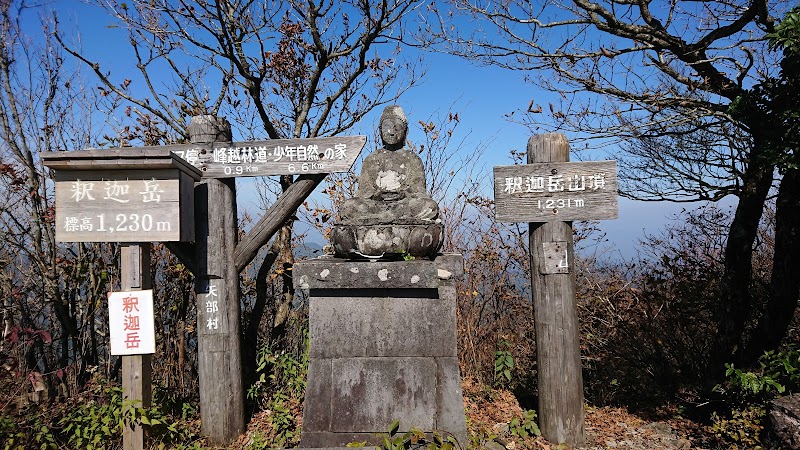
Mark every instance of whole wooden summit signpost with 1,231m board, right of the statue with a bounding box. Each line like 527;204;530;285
494;133;617;447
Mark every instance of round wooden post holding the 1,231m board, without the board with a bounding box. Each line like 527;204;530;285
528;133;586;447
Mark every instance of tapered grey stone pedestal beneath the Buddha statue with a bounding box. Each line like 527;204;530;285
293;255;467;448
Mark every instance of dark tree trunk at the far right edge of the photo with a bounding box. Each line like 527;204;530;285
742;169;800;363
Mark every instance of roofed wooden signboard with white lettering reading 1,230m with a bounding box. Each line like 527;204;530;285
42;148;205;242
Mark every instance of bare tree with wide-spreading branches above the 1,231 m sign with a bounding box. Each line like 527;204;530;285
428;0;796;375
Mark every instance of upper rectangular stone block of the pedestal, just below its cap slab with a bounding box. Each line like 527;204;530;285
309;291;457;358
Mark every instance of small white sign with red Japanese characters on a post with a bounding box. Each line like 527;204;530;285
108;289;156;355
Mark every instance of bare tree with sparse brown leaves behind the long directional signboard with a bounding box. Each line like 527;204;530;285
59;0;422;386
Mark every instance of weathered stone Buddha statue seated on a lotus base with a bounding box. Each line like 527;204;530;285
331;105;443;258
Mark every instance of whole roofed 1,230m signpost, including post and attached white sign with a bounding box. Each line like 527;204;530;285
42;148;200;450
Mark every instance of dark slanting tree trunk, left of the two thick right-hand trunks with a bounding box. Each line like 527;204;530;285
706;144;775;386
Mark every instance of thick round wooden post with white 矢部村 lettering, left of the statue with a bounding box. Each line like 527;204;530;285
189;115;244;445
